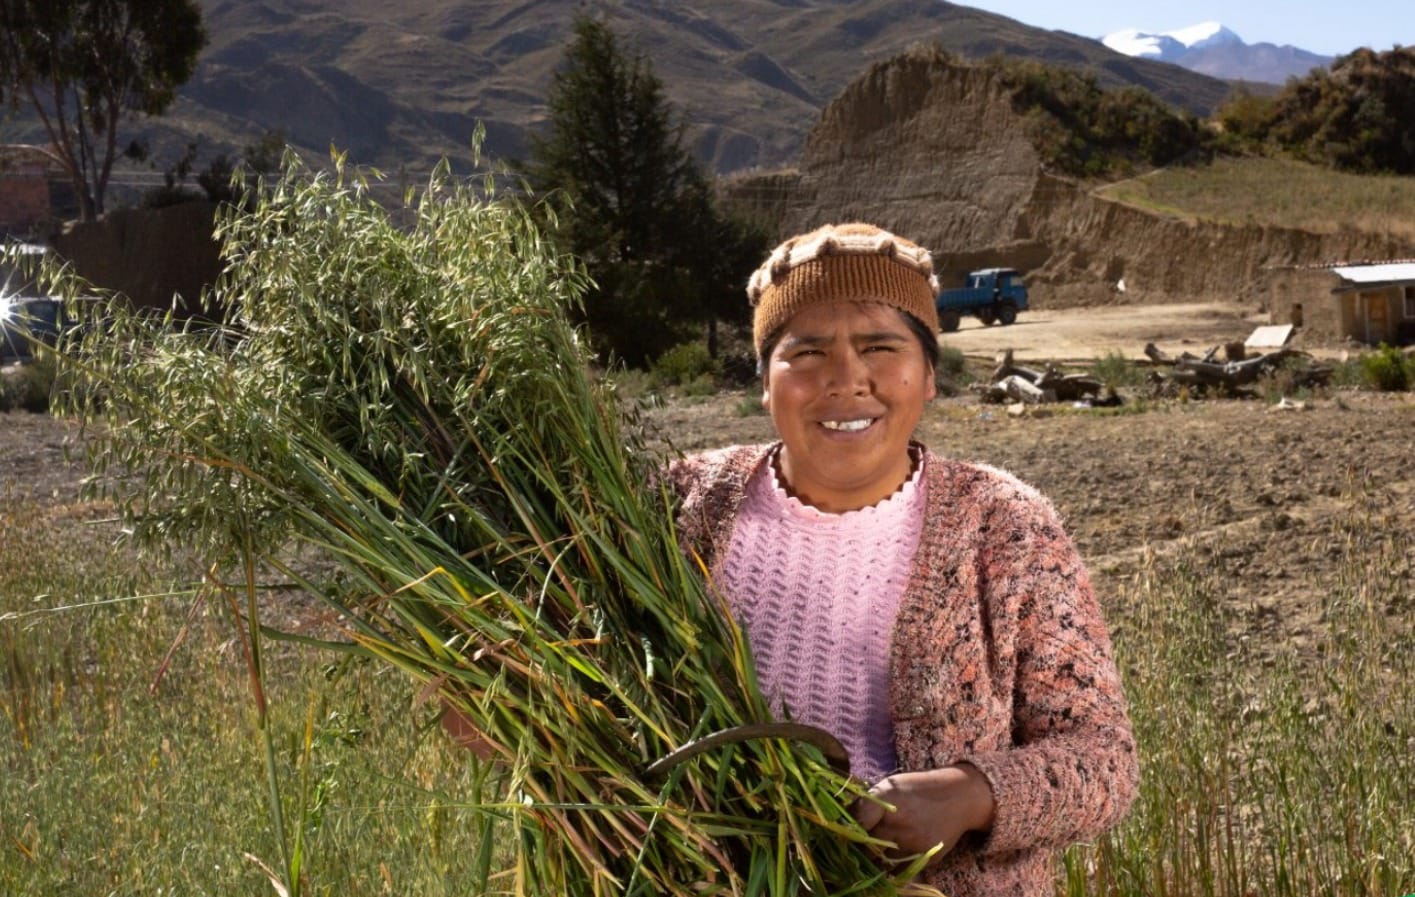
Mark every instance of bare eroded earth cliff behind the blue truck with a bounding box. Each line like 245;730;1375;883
727;50;1415;307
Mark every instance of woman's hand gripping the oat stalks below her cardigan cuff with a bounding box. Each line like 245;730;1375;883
855;763;995;859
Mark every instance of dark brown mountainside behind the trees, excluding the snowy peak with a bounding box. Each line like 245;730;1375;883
0;0;1230;183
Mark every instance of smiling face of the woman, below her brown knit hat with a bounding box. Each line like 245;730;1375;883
761;301;934;514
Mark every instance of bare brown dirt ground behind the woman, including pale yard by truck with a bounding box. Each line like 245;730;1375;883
0;299;1415;649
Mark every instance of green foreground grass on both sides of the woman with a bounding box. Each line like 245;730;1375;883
0;435;1415;897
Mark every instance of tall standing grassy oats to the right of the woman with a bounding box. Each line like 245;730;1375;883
1063;495;1415;897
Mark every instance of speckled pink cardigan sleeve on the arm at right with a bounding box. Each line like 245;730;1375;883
964;490;1139;853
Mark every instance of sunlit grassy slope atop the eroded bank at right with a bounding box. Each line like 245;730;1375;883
1101;158;1415;239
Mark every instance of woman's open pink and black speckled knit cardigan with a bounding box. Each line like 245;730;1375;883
668;446;1138;897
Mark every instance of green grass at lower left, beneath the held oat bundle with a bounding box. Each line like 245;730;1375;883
0;499;495;897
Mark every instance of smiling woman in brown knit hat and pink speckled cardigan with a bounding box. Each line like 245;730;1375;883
671;224;1136;897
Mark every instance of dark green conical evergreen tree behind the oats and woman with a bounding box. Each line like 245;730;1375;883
521;16;766;365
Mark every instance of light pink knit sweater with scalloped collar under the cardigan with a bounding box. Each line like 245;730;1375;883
716;447;924;782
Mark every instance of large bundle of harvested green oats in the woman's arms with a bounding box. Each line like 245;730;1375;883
55;160;939;896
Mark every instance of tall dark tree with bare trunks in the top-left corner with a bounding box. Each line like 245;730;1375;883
0;0;207;221
